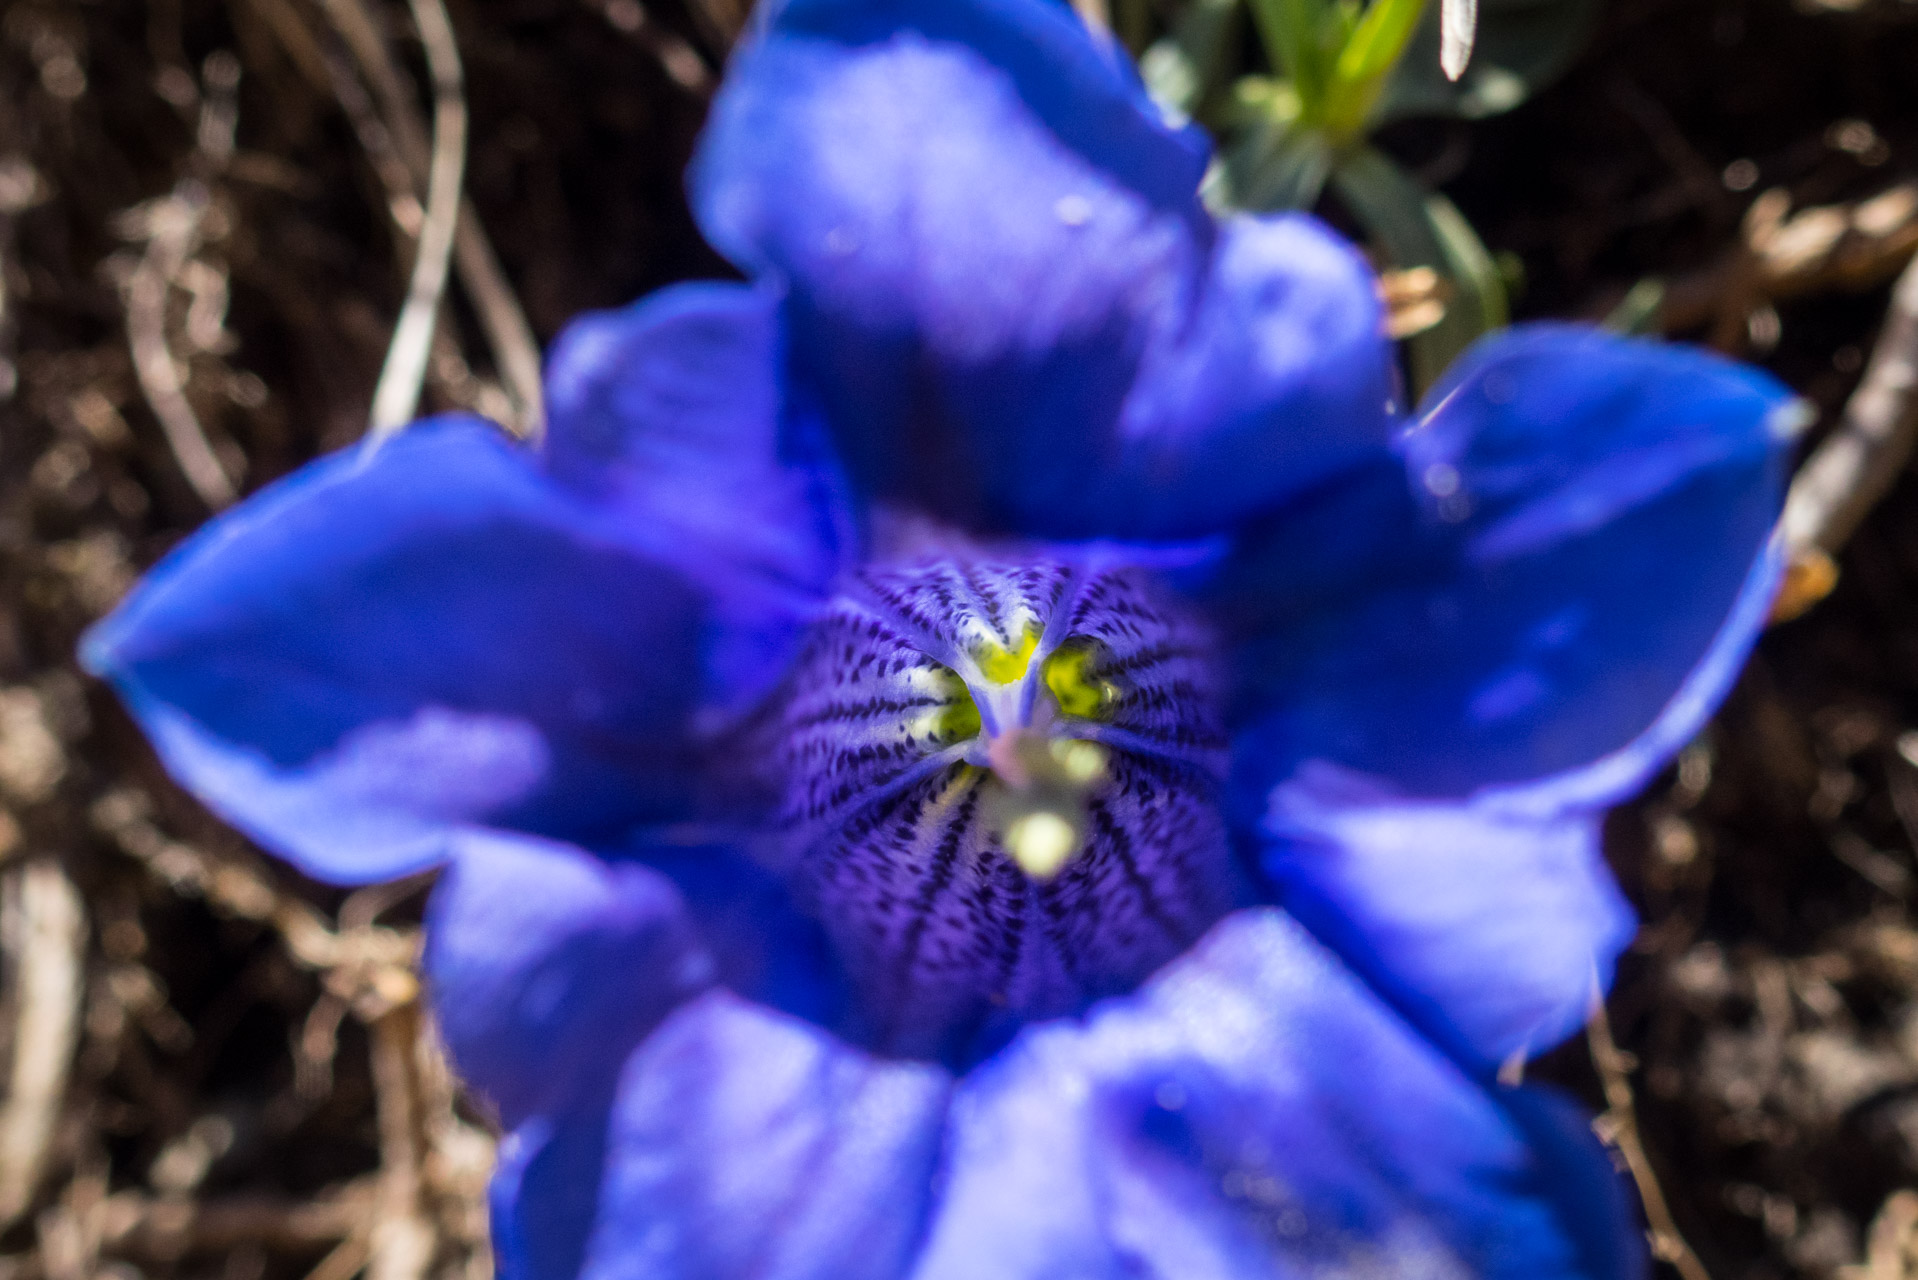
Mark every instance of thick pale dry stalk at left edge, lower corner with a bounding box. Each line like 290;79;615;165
0;858;86;1226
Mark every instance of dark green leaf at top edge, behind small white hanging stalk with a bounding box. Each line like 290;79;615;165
1377;0;1598;123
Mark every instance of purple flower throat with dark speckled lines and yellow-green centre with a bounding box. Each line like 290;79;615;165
759;560;1237;1055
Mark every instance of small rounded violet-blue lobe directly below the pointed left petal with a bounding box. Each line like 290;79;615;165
424;833;715;1126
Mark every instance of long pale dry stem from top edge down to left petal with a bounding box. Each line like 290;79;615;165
372;0;466;441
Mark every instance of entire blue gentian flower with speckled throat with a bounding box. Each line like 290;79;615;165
86;0;1789;1280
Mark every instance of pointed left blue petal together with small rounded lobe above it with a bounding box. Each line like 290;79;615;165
82;286;842;883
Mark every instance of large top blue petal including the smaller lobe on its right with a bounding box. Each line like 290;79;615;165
692;0;1391;539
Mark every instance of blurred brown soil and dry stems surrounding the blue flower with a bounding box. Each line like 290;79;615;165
0;0;1918;1280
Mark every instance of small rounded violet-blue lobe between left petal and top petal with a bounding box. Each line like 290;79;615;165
545;282;852;702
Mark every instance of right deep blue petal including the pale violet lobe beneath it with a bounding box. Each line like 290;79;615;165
1201;326;1791;1063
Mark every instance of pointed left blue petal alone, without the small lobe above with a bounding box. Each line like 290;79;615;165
84;420;708;881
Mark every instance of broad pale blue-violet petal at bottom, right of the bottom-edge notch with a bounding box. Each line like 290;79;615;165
915;910;1642;1280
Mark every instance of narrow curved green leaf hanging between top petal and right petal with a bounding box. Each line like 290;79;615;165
1331;146;1508;393
